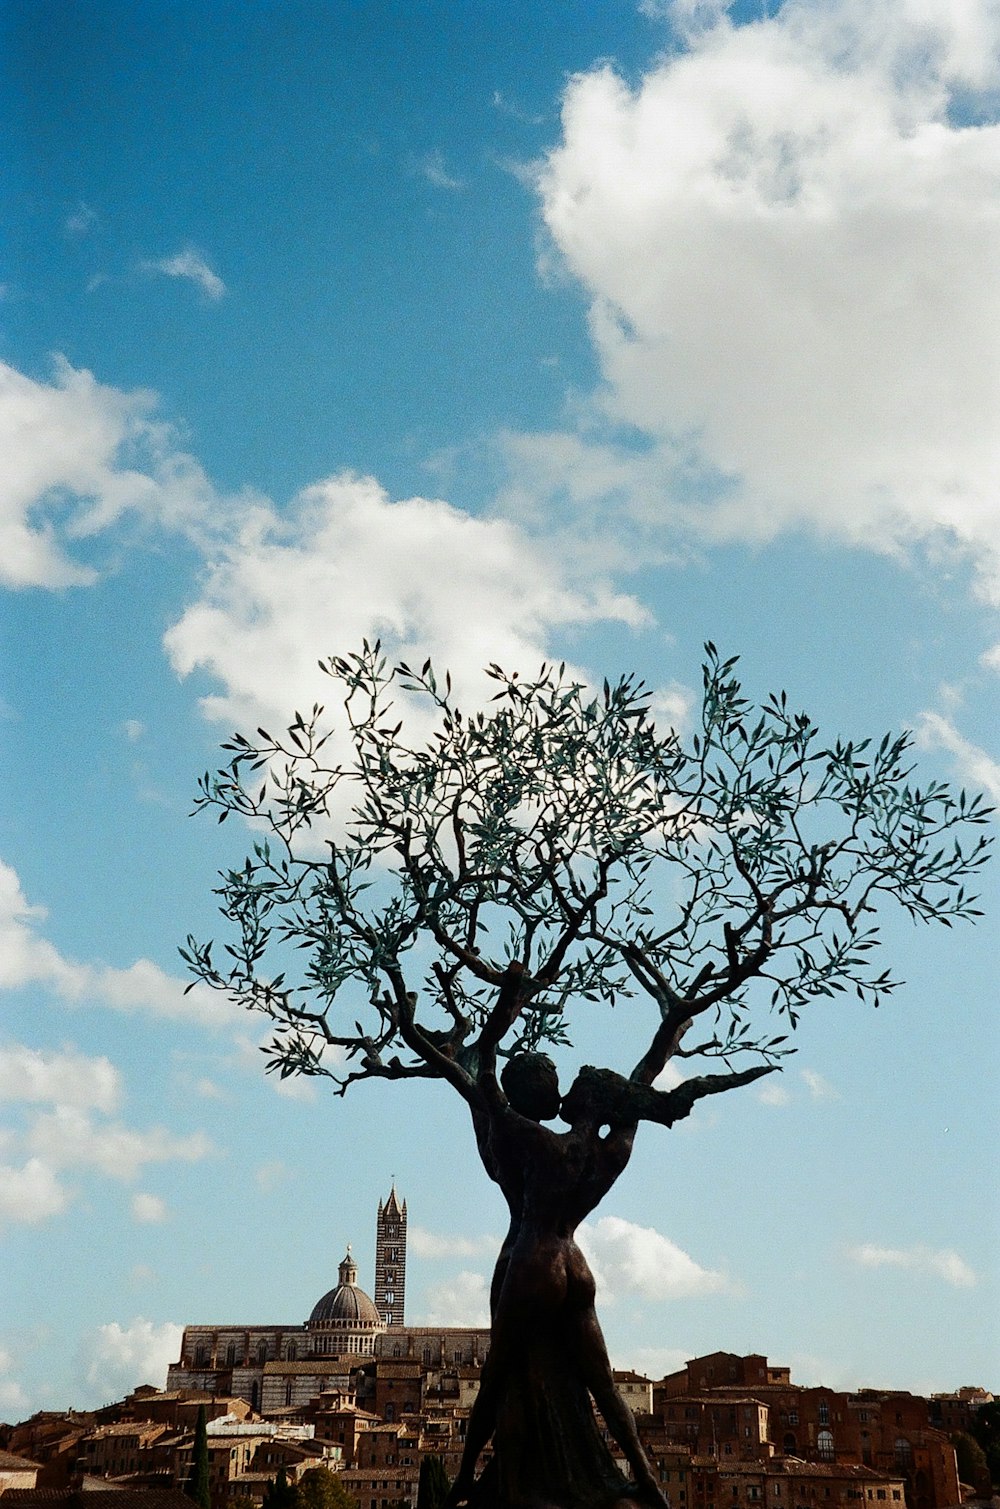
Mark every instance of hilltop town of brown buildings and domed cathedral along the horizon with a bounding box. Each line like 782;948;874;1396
39;1207;992;1509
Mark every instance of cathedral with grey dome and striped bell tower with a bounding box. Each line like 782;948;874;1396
166;1186;489;1414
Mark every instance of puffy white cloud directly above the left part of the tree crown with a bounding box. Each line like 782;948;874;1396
166;474;644;727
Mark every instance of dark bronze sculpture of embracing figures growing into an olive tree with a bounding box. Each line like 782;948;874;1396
183;644;989;1509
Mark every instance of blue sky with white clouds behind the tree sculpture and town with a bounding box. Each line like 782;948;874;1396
0;0;1000;1418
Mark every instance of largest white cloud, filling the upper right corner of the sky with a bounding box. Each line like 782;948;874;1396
536;0;1000;602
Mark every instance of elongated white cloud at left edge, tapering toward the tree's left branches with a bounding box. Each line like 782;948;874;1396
0;860;240;1032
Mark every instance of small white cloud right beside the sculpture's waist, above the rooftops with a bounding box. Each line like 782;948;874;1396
576;1216;733;1302
